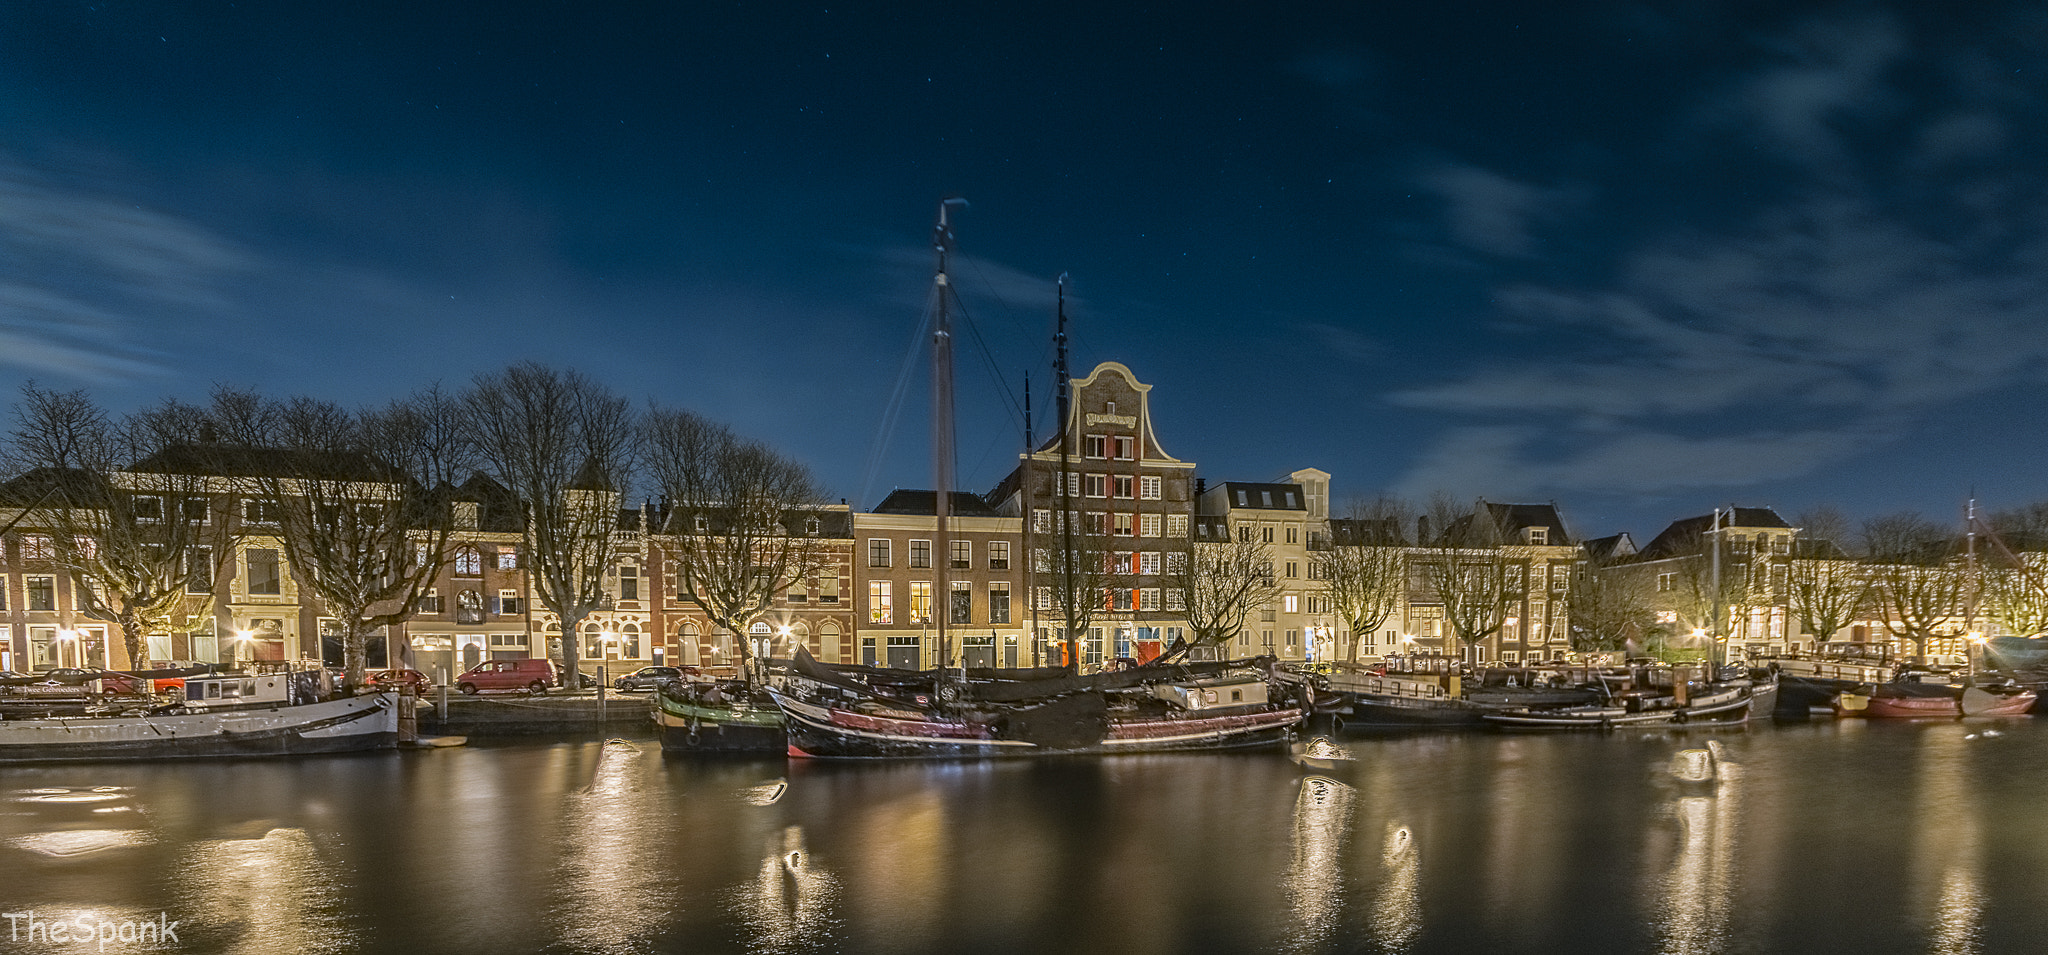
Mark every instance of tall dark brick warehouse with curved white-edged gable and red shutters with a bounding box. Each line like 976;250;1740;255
989;361;1194;666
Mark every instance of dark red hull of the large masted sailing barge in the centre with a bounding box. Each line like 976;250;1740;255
776;693;1305;760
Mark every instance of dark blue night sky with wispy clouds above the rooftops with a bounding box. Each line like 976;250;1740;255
0;0;2048;541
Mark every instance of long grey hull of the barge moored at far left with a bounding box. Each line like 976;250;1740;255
0;693;397;764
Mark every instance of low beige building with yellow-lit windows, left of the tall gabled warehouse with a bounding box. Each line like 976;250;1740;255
852;490;1030;670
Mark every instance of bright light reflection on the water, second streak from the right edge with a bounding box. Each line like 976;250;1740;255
1657;750;1741;955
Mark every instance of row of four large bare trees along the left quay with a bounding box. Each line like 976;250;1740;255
6;363;823;684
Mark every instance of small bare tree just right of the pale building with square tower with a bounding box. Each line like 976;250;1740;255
1311;498;1413;662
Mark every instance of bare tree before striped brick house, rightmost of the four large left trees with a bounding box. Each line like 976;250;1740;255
643;408;825;680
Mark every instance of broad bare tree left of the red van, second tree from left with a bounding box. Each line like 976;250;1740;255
200;387;469;687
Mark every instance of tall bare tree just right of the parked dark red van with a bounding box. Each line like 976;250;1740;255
463;361;639;689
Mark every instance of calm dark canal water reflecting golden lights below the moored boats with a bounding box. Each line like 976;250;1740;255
0;719;2048;955
